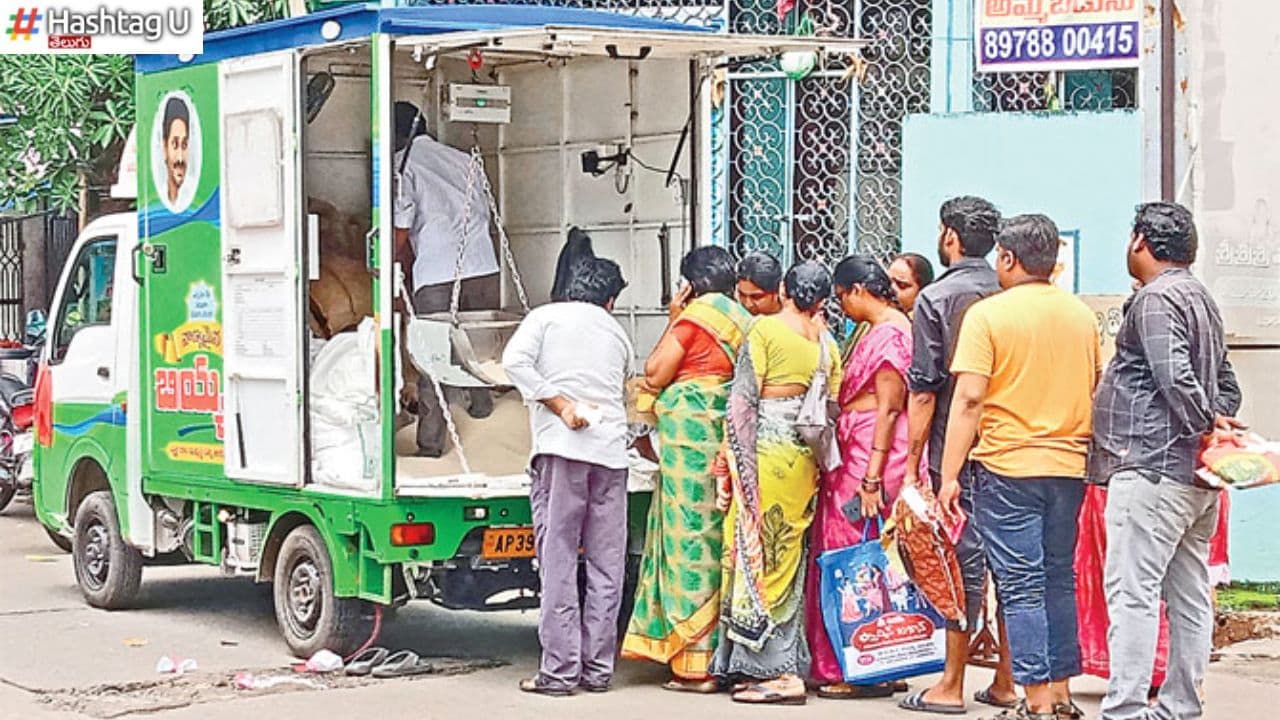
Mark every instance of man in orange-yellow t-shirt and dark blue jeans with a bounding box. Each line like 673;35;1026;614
938;215;1102;720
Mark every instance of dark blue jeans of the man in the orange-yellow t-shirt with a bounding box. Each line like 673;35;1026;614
973;464;1084;685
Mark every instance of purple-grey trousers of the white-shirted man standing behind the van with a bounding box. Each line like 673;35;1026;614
529;455;627;689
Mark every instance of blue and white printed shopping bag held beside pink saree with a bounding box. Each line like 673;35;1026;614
818;517;946;684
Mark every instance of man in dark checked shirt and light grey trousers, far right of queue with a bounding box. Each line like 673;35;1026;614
1089;202;1240;720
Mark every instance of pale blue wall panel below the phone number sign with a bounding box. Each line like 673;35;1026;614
902;113;1142;295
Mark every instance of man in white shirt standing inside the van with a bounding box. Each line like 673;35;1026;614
394;102;499;457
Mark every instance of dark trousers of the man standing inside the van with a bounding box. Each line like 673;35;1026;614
413;274;499;456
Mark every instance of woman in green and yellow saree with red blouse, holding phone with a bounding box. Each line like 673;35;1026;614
622;247;751;693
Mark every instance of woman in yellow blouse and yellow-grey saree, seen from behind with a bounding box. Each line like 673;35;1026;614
712;263;841;705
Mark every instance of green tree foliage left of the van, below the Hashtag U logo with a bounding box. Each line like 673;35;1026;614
0;55;133;210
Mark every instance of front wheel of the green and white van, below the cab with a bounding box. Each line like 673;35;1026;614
72;489;142;610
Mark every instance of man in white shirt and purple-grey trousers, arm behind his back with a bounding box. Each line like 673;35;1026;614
502;259;632;696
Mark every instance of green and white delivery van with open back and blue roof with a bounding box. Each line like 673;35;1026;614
35;5;855;655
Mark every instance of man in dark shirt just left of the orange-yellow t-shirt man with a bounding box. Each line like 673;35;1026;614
902;197;1018;711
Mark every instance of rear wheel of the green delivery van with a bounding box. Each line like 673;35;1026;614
271;525;372;657
